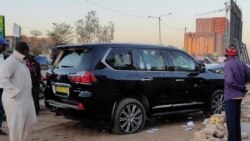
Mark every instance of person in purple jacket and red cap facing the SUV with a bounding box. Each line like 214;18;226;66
224;45;250;141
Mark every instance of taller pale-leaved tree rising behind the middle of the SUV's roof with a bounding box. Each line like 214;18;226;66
76;11;114;43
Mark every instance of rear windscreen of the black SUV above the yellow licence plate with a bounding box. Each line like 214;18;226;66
58;48;91;68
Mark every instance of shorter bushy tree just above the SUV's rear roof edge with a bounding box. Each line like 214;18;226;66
47;23;74;45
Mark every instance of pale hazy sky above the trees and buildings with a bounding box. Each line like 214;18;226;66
0;0;250;48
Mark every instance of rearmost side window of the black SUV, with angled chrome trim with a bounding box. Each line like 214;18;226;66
105;48;135;70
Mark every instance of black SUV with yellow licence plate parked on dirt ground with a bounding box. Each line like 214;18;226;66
45;43;224;134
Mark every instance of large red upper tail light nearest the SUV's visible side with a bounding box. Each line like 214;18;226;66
68;71;97;83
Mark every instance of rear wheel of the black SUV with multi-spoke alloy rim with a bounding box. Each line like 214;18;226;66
113;98;146;134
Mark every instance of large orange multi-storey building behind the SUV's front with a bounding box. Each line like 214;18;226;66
184;17;228;57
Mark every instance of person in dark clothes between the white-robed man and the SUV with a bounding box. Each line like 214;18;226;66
26;56;41;115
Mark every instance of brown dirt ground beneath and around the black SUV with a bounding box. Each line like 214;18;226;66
0;85;250;141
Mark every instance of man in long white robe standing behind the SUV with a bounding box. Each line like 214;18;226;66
0;42;36;141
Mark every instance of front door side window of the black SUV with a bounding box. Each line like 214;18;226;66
169;51;196;71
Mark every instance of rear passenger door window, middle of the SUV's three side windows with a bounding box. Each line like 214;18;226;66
139;49;165;71
